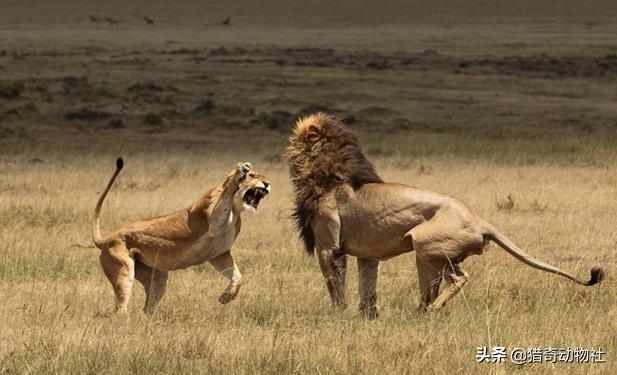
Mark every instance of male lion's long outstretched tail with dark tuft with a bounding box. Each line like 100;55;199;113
486;223;604;286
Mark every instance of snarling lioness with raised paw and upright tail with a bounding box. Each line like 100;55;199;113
92;159;270;313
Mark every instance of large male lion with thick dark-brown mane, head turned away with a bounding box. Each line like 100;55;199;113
286;113;604;318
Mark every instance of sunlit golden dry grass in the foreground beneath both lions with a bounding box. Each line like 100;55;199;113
0;137;617;373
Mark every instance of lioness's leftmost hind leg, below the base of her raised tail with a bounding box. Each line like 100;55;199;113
99;243;135;313
